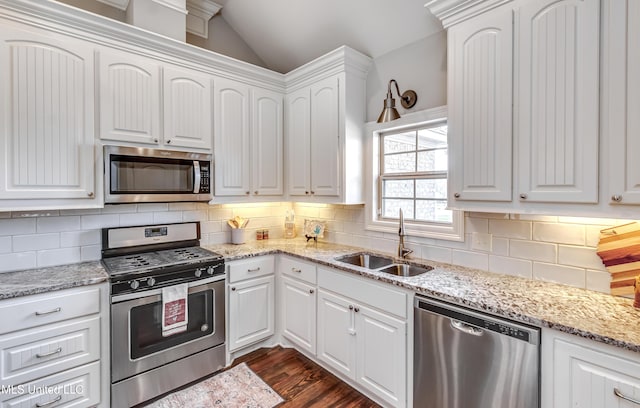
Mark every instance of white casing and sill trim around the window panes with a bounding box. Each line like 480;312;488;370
365;106;464;242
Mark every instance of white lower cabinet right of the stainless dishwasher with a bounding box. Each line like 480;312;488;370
542;329;640;408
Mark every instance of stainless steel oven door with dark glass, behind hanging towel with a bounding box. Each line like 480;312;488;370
111;277;225;383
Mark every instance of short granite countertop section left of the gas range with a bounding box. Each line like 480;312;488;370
0;261;109;300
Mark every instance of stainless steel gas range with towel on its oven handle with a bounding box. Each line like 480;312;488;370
102;222;225;408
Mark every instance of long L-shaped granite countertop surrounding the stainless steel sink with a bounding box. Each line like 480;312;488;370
207;239;640;352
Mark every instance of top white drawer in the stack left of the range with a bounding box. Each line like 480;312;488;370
0;288;100;334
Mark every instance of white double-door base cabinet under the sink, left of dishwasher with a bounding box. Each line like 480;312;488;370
317;268;407;407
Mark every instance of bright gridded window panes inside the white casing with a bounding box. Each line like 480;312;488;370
378;122;453;224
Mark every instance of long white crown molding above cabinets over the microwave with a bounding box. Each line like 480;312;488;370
0;0;285;92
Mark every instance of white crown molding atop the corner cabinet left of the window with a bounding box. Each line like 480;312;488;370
284;45;372;92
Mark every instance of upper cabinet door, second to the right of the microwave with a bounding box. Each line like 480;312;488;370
251;88;284;195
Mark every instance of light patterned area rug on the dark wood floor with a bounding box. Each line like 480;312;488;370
146;363;283;408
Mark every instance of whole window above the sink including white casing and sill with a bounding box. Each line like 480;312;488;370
365;106;464;241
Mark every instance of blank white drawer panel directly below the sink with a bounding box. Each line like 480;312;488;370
318;268;407;319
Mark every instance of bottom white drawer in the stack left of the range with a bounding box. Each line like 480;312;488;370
0;361;100;408
